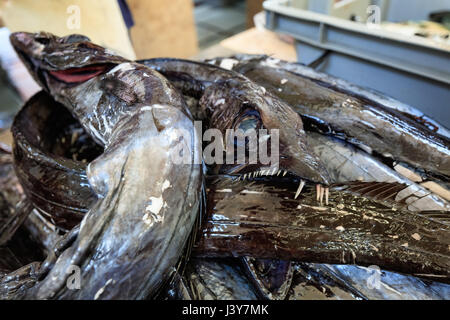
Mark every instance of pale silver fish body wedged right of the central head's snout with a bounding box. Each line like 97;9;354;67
307;132;450;211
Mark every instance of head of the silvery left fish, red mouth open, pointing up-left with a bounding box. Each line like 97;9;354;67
10;32;142;145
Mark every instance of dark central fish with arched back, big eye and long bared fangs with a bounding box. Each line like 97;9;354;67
139;58;332;200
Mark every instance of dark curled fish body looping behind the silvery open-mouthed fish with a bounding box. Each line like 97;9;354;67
11;91;103;230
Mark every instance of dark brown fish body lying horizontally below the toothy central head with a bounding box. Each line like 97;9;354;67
194;179;450;282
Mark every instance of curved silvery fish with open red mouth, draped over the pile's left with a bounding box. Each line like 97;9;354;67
11;33;202;299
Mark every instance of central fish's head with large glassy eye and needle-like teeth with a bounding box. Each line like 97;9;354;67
205;79;331;185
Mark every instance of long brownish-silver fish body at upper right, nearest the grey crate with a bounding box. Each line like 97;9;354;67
207;58;450;176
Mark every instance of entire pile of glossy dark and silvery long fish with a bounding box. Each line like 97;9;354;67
0;32;450;299
